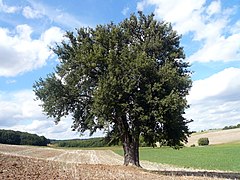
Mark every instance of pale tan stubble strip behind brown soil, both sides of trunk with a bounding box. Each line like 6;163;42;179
0;144;193;171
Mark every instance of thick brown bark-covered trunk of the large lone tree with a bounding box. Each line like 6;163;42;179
123;133;141;167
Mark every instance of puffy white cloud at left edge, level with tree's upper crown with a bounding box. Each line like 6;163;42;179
0;24;63;77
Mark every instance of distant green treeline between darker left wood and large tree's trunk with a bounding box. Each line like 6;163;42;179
51;137;108;147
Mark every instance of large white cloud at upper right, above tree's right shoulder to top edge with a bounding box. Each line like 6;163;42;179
137;0;240;62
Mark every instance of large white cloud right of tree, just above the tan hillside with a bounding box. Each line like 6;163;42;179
186;68;240;130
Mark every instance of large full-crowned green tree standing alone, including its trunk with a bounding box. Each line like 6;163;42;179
33;12;191;166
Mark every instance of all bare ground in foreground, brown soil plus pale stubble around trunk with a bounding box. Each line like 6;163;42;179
0;144;232;180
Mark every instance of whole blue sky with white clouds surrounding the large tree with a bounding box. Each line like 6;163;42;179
0;0;240;139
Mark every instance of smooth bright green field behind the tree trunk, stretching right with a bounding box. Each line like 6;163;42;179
114;143;240;172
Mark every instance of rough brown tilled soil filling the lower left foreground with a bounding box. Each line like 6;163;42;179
0;154;165;180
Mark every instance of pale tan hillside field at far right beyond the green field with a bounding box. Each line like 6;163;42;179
187;128;240;146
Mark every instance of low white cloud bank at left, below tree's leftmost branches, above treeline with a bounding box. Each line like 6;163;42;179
0;90;103;139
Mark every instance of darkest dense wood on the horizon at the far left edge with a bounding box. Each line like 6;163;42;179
0;129;50;146
